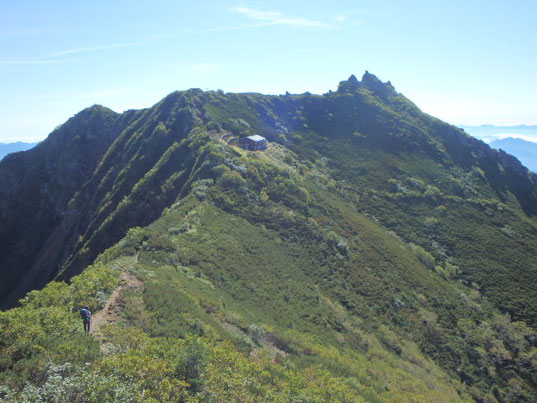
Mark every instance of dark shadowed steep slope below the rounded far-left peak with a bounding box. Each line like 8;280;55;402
0;106;136;306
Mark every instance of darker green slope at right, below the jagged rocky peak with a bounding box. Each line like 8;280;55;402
292;131;537;323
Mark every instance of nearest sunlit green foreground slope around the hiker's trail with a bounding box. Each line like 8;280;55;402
0;198;468;401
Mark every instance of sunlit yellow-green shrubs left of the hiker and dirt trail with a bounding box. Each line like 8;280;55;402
0;265;118;393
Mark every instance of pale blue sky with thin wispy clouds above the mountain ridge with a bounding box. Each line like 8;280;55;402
0;0;537;142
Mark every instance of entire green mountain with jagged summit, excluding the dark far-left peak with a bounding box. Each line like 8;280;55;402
0;73;537;401
